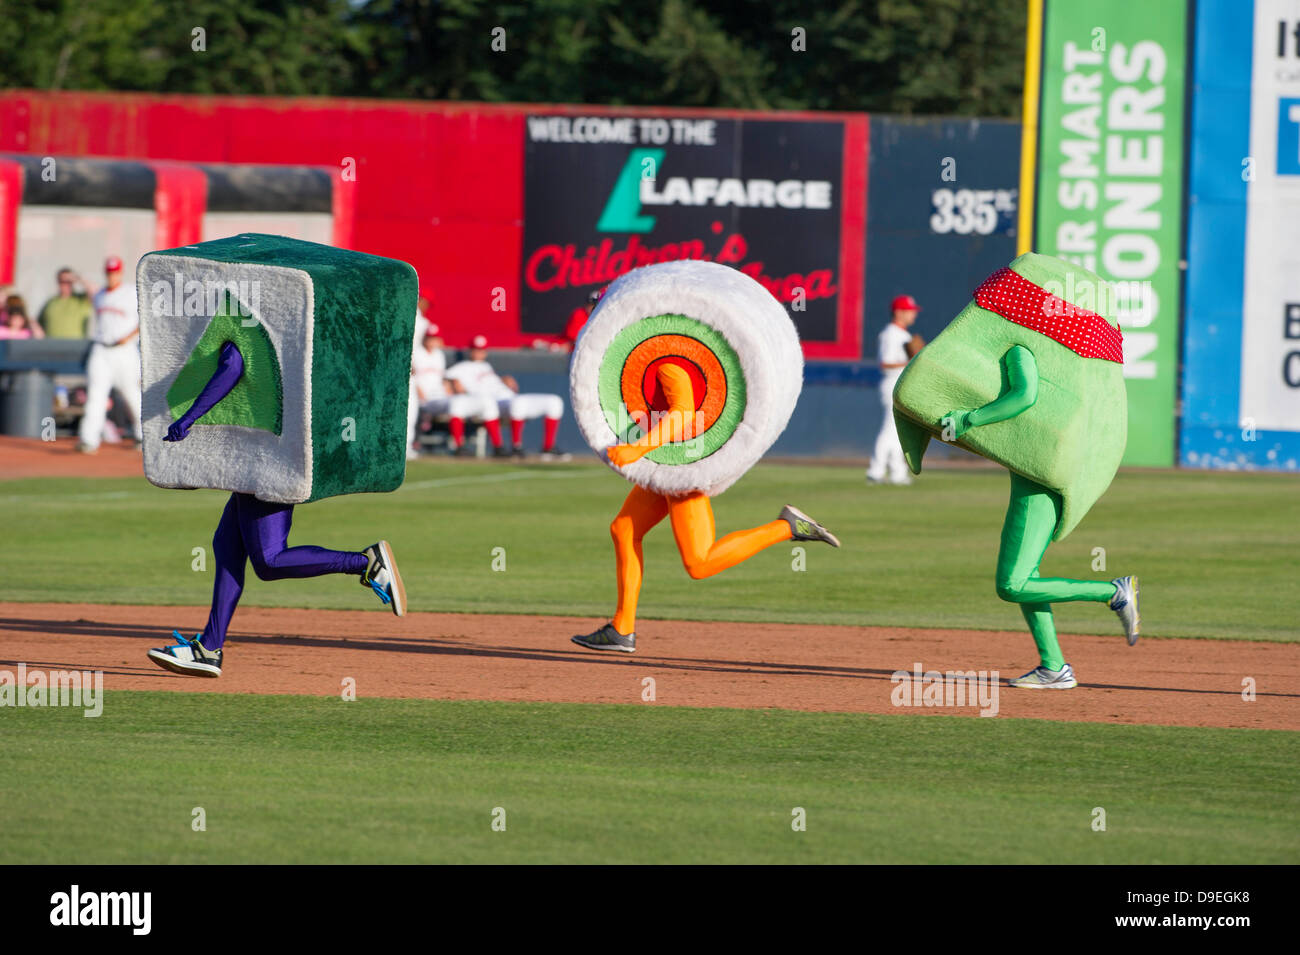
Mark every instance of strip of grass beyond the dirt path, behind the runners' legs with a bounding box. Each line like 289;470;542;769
0;460;1300;641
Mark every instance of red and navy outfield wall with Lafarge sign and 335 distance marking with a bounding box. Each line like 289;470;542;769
0;91;1019;361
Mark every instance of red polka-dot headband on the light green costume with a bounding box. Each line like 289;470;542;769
975;268;1125;364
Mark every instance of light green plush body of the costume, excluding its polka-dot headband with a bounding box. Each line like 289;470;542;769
894;252;1128;541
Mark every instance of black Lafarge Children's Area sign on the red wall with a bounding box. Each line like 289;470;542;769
520;114;844;343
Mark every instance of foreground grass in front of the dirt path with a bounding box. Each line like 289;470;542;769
0;691;1300;864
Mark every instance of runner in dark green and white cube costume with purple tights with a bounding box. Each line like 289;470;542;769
137;235;417;677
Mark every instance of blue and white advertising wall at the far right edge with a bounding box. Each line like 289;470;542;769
1179;0;1300;470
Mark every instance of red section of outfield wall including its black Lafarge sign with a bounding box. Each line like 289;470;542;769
0;91;868;359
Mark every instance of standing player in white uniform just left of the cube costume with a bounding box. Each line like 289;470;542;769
77;256;142;453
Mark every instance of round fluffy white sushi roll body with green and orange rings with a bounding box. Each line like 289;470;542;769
569;260;803;496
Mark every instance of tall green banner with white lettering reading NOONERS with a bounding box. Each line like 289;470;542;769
1035;0;1187;466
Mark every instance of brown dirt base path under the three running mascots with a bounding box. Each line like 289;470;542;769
0;603;1300;730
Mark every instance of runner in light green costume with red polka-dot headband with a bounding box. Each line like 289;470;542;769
894;252;1139;690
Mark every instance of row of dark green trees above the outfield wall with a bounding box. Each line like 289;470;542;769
0;0;1026;116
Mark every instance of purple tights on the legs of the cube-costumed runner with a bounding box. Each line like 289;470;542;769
200;494;369;650
